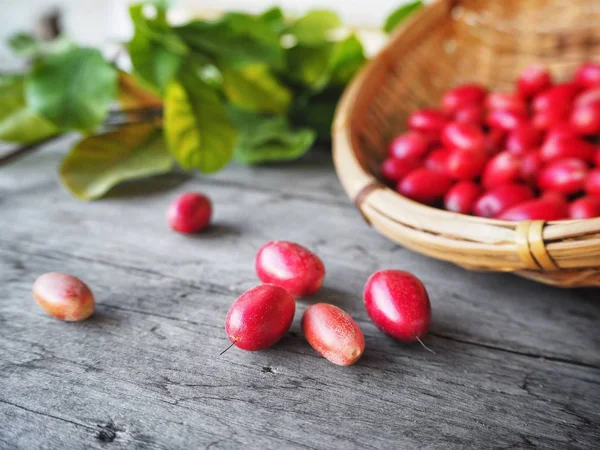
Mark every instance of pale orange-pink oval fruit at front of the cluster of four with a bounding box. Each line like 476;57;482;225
302;303;365;366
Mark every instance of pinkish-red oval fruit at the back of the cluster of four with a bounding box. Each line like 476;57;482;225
255;241;325;297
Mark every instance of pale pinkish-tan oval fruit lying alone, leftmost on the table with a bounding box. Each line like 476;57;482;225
33;272;95;322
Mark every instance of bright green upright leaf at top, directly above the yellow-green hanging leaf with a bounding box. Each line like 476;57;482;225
127;5;187;92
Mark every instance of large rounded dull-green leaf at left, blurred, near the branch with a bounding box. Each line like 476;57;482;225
25;48;117;131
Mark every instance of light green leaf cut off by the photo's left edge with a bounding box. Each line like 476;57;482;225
0;75;58;144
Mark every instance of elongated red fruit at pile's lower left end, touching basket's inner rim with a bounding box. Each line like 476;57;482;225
397;168;452;203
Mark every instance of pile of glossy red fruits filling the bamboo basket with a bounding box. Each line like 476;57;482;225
381;63;600;220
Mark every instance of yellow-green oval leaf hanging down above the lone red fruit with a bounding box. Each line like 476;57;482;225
164;77;237;172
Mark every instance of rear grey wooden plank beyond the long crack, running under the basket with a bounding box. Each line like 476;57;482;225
0;146;600;367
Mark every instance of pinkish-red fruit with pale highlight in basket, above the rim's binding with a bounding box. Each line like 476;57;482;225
538;158;588;194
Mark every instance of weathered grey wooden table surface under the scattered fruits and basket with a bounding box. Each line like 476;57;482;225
0;140;600;449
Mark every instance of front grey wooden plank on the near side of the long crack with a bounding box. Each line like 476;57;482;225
0;250;600;448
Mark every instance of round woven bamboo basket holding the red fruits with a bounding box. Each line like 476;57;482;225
332;0;600;287
